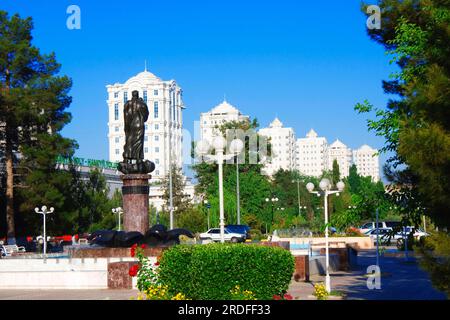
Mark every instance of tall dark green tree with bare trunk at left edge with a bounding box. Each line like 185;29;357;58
0;11;76;241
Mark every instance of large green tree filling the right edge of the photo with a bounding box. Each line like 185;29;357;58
356;0;450;227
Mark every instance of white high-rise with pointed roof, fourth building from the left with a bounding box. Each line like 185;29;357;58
296;129;327;177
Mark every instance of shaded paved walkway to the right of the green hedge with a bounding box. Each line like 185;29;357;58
289;250;446;300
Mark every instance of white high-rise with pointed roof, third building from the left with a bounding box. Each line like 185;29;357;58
258;118;297;176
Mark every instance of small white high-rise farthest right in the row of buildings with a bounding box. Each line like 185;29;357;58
353;144;380;182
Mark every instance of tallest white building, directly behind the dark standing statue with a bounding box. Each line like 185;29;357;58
106;70;185;180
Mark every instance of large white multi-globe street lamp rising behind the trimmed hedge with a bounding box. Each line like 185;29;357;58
196;136;243;243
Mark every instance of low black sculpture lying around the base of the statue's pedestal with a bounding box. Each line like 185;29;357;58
88;225;194;248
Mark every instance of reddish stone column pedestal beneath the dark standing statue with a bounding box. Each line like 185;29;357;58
121;174;151;234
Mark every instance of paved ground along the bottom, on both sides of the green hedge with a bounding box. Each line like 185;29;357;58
0;250;446;300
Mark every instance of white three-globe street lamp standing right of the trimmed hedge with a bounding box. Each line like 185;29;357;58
306;179;345;293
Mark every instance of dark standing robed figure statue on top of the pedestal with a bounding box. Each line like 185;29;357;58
119;90;155;174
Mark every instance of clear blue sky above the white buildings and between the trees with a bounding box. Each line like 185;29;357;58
0;0;394;180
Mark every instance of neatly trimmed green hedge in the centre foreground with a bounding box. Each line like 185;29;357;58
159;244;294;300
